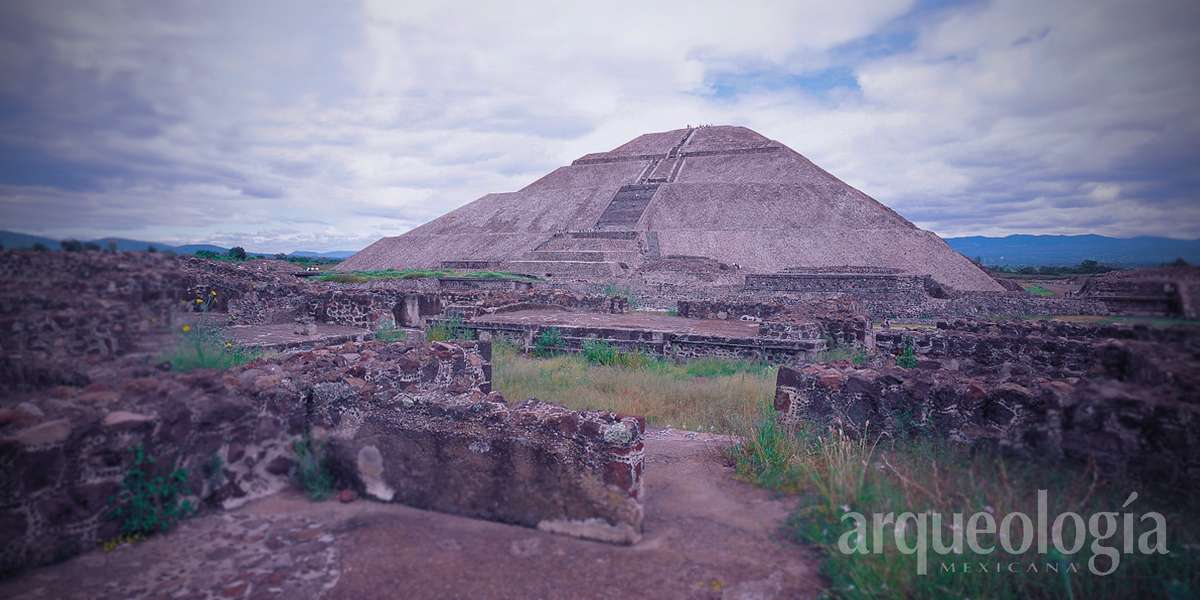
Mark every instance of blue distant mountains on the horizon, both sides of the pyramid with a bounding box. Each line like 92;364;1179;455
0;230;1200;266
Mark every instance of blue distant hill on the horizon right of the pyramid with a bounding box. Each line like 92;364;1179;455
946;235;1200;266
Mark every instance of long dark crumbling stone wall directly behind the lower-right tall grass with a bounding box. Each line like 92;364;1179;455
774;366;1200;485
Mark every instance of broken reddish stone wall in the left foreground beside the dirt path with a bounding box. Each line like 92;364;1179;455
0;342;644;571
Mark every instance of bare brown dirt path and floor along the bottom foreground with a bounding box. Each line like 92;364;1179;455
0;430;821;600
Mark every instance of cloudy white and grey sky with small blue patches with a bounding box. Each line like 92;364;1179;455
0;0;1200;251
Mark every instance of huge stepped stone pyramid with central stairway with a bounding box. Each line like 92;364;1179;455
340;126;1002;292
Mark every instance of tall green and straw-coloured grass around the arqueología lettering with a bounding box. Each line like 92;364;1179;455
730;415;1200;598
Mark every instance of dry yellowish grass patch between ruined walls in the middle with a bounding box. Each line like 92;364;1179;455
493;344;775;432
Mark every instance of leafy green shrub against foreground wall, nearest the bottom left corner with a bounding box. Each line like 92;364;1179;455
109;444;194;535
